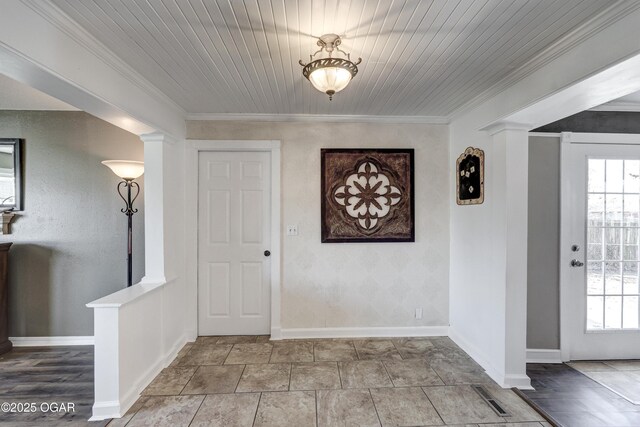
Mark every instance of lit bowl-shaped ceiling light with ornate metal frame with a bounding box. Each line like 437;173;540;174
298;34;362;101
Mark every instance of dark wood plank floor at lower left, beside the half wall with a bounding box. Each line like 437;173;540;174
0;346;106;426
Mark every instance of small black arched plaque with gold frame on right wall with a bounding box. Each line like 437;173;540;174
456;147;484;205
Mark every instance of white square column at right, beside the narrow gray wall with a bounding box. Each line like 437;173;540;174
486;123;531;388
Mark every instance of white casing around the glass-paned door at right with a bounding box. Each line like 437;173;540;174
560;132;640;362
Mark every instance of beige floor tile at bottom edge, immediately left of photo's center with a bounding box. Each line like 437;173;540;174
254;391;316;427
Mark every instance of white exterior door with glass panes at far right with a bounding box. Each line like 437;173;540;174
561;143;640;360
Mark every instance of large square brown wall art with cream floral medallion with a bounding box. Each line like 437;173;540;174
320;148;415;243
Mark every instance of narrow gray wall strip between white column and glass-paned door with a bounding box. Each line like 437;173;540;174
527;137;560;349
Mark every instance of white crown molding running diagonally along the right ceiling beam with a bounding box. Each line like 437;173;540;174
448;2;640;120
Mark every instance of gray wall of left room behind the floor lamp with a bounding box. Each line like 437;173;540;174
0;111;144;337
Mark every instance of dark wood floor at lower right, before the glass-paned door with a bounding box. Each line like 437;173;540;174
525;364;640;427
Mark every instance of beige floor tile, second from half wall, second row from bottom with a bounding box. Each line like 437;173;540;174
182;365;244;394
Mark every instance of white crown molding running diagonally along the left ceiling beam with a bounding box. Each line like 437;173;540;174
21;0;186;117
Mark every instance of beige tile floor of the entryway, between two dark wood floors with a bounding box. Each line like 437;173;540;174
109;336;549;427
